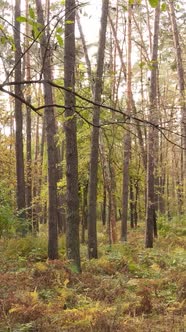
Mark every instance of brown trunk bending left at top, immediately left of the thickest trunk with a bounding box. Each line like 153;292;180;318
36;0;58;259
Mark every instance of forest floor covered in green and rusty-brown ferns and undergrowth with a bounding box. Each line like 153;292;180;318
0;219;186;332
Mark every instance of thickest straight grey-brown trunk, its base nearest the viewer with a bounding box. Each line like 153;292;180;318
64;0;81;271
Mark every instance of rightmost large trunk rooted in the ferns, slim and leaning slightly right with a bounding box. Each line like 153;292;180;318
145;4;160;248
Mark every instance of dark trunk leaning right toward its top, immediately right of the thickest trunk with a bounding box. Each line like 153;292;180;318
88;0;109;259
